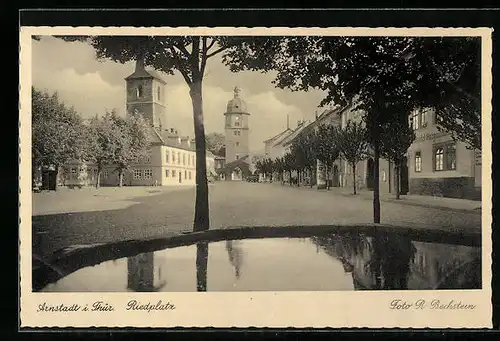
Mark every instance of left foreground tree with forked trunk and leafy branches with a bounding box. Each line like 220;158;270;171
47;36;248;231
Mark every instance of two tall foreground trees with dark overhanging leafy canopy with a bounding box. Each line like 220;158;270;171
43;36;481;231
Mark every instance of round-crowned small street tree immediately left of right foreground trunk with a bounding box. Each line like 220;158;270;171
334;121;368;194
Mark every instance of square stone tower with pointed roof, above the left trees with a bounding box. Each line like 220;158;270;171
125;58;166;130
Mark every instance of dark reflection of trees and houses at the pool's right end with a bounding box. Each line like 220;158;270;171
312;233;481;290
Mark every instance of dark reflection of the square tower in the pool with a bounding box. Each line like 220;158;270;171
127;252;167;292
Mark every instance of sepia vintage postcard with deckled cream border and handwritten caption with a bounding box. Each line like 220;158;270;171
19;27;492;328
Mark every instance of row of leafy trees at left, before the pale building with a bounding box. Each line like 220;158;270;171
32;88;150;187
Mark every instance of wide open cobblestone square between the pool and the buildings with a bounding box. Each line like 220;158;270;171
33;182;481;257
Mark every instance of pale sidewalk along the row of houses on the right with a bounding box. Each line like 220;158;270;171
266;182;482;214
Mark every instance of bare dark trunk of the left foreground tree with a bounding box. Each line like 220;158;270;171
189;77;210;232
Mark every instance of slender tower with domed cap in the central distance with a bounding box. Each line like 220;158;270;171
224;87;250;163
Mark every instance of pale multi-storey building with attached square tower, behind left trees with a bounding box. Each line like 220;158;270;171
55;60;215;187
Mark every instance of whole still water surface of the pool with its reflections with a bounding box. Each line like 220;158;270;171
42;233;481;292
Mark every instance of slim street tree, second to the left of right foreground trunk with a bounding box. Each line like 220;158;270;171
314;124;340;189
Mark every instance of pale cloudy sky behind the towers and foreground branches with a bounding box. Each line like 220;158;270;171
32;37;324;151
